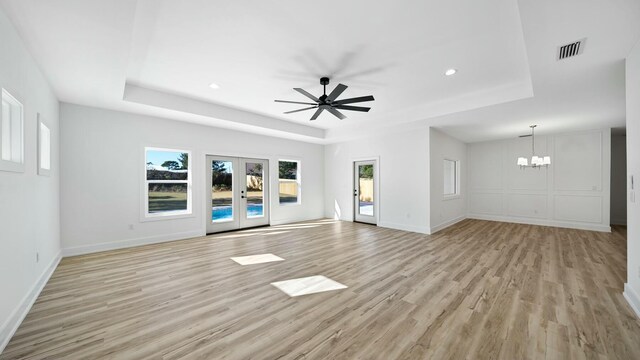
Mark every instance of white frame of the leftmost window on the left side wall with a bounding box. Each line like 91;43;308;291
0;88;25;172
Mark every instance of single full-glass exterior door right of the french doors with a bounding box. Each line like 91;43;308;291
353;160;378;224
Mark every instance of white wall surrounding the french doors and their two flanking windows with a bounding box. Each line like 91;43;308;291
60;103;324;254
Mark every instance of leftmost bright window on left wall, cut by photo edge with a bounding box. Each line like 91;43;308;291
0;89;24;172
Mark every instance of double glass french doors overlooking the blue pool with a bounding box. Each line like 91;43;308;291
206;155;269;233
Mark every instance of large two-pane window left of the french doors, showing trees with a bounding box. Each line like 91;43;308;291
144;148;191;218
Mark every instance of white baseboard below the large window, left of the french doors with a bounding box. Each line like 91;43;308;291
62;230;205;257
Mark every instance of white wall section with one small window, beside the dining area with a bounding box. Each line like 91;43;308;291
429;128;467;234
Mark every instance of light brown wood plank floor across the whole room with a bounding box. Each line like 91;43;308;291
0;220;640;359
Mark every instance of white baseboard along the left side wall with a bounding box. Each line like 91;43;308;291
0;252;62;354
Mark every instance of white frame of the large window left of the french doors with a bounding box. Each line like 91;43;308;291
140;146;194;222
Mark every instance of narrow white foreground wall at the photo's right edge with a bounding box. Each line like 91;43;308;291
624;42;640;317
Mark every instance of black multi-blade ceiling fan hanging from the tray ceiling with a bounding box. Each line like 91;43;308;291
275;77;375;120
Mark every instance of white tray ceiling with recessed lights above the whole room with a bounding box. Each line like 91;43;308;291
0;0;640;143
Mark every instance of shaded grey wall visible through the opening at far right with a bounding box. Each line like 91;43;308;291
611;134;627;225
